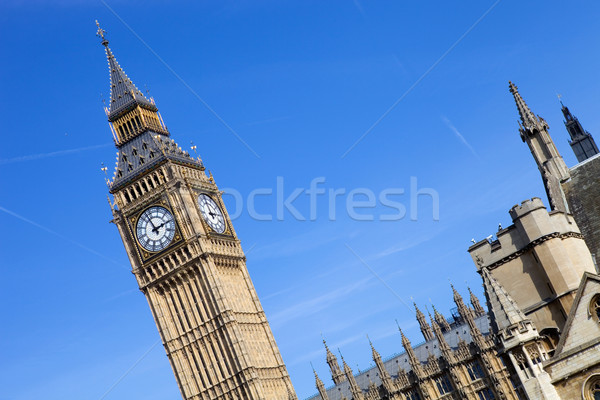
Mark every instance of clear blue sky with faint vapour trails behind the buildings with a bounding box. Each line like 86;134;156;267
0;0;600;400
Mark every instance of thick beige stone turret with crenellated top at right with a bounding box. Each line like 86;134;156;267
469;197;595;331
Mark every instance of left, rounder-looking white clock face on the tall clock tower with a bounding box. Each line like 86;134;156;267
135;206;175;252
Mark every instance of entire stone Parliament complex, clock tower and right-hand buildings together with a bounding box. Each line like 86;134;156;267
98;23;600;400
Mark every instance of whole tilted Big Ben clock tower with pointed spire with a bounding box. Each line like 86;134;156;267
98;23;296;400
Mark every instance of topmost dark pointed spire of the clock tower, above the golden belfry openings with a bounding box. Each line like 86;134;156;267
96;21;158;122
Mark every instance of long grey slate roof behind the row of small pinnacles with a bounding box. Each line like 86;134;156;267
306;315;491;400
